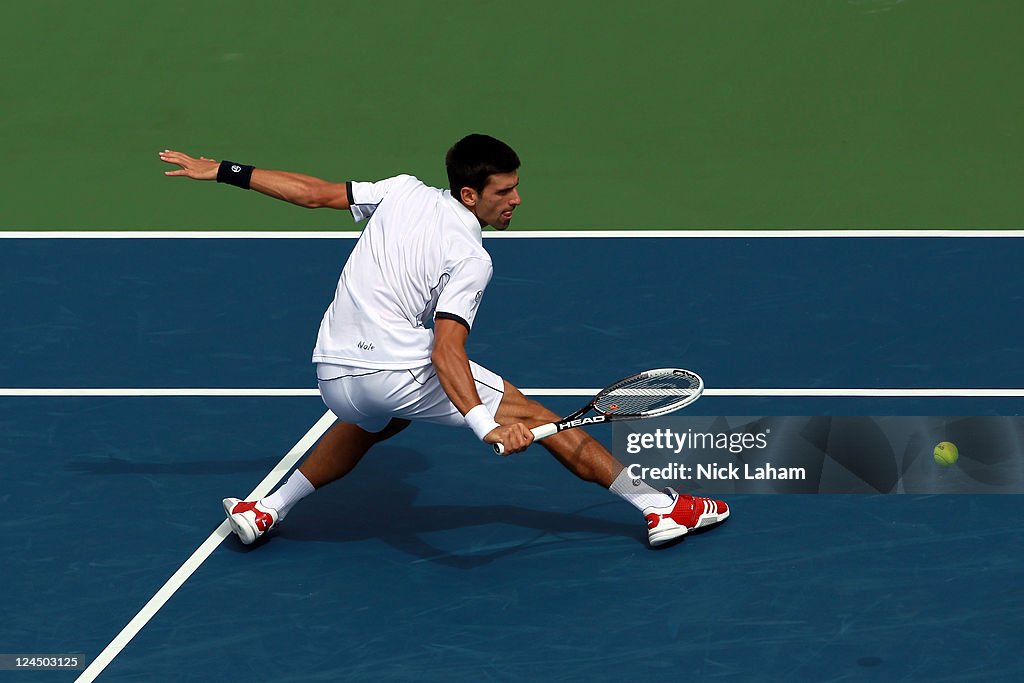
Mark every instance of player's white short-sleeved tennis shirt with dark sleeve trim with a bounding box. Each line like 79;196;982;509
312;175;494;370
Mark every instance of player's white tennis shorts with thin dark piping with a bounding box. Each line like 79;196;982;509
316;360;505;432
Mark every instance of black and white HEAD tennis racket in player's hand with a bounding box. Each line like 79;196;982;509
495;368;703;456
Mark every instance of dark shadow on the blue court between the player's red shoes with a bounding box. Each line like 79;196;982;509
276;446;646;569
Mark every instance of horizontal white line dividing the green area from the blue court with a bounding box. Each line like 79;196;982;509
0;228;1024;240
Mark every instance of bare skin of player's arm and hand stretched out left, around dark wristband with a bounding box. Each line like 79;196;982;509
160;150;349;210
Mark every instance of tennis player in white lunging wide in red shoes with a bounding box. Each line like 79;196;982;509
160;134;729;546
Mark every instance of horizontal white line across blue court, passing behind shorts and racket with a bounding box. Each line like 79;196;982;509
6;387;1024;398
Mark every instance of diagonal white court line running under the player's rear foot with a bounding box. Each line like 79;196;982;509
76;411;335;683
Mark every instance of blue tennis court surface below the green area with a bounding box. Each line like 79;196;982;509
0;233;1024;681
